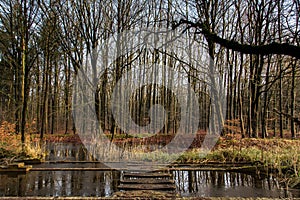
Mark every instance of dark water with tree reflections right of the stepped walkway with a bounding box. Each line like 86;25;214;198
173;171;300;198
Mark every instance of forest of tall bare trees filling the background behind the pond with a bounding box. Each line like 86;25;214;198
0;0;300;198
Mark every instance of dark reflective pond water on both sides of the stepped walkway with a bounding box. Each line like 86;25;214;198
0;144;300;198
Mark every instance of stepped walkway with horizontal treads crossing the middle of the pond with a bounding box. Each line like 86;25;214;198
113;162;178;199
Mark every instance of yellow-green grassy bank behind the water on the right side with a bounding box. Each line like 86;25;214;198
175;138;300;171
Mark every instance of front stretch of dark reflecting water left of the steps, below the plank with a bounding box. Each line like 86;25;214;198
0;171;120;197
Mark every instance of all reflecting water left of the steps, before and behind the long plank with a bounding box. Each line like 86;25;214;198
0;143;120;197
